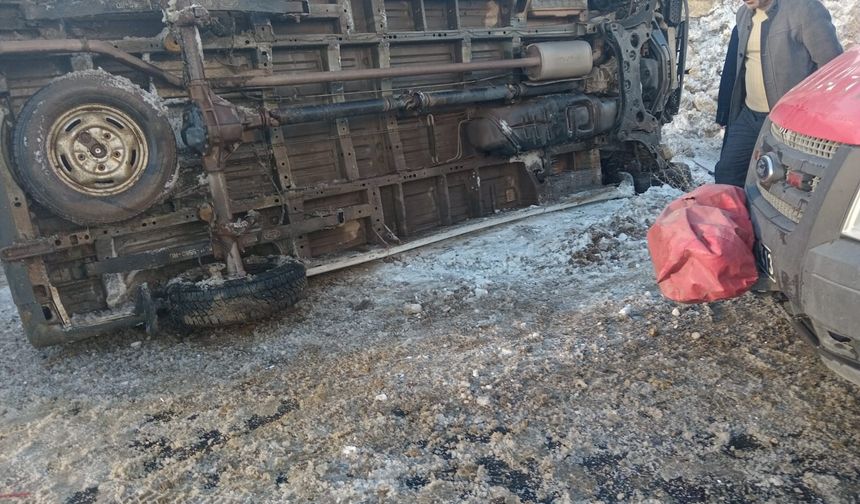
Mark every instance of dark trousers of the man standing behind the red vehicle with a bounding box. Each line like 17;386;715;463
714;105;767;187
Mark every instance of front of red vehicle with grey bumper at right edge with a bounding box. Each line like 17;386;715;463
746;47;860;384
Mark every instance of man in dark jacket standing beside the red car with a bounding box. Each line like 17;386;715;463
714;0;842;187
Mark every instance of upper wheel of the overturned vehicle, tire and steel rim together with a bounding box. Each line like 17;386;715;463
12;70;178;225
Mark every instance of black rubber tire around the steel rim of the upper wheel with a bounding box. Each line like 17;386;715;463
12;70;178;225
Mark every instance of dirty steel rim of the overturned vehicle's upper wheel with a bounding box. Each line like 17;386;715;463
46;103;149;196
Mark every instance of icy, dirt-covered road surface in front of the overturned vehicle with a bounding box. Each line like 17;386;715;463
0;157;860;503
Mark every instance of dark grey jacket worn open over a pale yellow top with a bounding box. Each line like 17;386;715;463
729;0;842;123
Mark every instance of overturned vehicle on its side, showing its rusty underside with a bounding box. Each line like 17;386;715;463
0;0;687;346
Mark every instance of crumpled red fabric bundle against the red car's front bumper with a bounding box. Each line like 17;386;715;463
648;184;758;303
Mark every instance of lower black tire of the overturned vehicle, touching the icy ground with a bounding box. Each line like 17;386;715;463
166;256;307;328
